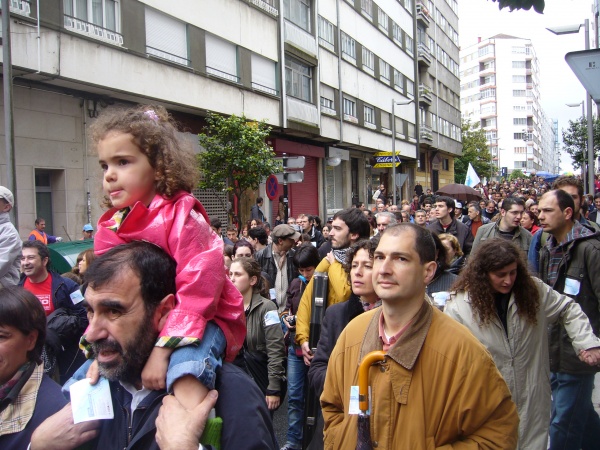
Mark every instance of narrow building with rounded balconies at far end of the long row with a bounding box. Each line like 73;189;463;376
416;0;462;192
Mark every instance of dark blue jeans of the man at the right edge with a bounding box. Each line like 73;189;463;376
550;372;600;450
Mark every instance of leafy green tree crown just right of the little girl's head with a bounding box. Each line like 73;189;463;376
198;113;279;210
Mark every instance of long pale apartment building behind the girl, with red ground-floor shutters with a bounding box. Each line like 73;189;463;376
0;0;426;238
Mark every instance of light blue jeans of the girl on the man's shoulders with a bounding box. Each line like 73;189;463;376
65;322;225;392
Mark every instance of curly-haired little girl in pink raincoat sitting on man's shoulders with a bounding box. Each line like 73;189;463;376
83;106;246;409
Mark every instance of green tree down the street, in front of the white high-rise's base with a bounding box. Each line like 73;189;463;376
454;120;495;184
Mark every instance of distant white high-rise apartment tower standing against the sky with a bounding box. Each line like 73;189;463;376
460;34;558;173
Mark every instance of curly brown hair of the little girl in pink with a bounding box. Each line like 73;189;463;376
90;105;199;207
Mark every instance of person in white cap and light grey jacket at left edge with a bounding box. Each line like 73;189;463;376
0;186;23;289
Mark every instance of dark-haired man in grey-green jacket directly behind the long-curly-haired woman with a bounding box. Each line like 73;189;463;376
473;197;531;259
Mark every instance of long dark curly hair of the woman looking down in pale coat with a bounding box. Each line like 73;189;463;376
452;238;540;326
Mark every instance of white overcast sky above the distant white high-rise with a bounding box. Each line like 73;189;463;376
458;0;595;170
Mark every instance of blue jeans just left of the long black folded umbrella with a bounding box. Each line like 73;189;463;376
286;345;308;449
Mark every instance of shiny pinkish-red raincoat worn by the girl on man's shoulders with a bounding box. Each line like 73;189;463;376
94;191;246;361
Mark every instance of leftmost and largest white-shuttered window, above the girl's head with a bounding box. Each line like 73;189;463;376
145;8;188;66
